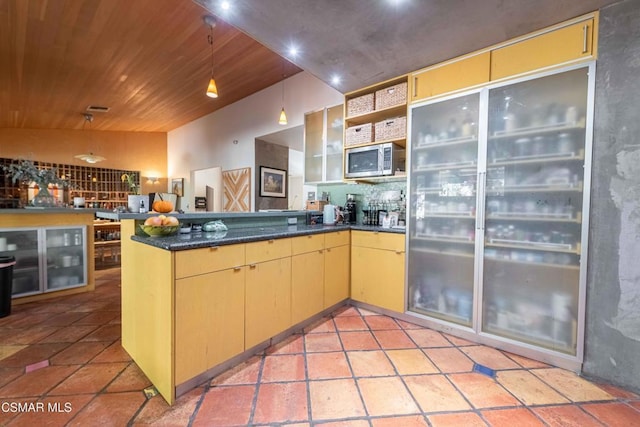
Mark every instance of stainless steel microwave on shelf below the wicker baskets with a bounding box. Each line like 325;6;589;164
344;142;405;178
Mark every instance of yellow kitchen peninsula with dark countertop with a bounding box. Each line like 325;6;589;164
118;211;404;404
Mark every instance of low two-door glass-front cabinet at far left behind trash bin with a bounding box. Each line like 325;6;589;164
0;226;88;297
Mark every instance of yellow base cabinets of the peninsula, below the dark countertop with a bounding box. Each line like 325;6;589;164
122;226;349;404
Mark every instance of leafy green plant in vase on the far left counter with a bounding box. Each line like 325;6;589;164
2;160;67;207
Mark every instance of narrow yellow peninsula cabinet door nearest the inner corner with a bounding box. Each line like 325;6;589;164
323;244;351;308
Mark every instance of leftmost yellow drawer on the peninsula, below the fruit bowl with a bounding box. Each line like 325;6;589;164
175;245;245;279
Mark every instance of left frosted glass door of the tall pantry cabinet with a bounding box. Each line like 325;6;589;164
408;93;479;326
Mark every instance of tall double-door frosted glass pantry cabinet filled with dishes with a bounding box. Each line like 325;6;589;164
408;64;594;360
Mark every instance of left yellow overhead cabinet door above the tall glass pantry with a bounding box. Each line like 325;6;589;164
411;52;491;102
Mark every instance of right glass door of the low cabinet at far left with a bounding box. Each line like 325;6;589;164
44;227;87;291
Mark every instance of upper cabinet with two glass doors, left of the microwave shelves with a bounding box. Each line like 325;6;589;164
304;104;344;183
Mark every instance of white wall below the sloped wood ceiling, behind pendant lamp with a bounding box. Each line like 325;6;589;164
167;72;344;211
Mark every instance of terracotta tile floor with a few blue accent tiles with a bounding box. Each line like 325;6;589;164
0;269;640;427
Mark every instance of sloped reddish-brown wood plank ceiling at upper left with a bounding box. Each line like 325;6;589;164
0;0;301;132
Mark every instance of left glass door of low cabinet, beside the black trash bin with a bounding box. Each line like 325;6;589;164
0;229;42;296
